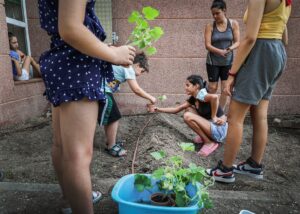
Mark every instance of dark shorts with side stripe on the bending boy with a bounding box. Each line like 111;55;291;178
98;93;122;126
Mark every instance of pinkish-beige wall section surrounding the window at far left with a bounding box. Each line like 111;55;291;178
0;0;49;127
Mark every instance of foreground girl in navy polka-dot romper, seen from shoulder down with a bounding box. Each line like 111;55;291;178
38;0;135;214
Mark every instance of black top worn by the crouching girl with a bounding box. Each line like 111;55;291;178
187;96;224;120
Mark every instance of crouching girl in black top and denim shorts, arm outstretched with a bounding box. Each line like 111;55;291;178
149;75;228;157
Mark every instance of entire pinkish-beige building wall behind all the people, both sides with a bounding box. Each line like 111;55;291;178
0;0;300;127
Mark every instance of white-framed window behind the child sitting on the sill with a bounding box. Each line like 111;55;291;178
4;0;31;55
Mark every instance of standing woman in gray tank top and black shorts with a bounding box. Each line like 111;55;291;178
205;0;240;110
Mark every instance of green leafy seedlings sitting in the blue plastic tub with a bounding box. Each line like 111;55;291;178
135;143;214;208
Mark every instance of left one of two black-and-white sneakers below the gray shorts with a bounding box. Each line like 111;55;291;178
206;161;235;183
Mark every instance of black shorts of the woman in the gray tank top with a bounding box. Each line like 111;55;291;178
206;64;231;82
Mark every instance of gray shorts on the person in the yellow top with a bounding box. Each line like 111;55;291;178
232;39;287;105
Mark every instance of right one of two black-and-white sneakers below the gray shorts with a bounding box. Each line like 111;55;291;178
233;157;264;179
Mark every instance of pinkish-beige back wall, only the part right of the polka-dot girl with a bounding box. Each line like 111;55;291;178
112;0;300;115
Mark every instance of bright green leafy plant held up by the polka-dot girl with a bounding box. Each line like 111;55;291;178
126;7;164;55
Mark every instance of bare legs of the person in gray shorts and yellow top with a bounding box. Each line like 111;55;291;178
223;100;269;168
